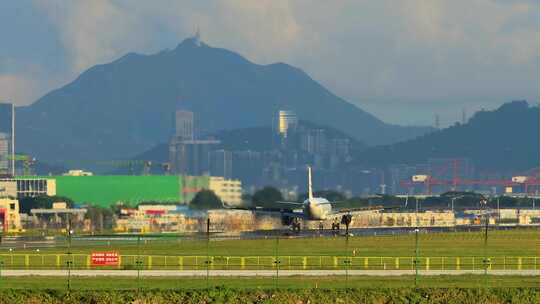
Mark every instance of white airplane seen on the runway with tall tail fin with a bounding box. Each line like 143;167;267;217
236;166;383;231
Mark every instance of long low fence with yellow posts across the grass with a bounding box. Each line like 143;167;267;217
0;254;540;270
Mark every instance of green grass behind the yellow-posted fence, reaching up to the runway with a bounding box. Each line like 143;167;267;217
4;229;540;256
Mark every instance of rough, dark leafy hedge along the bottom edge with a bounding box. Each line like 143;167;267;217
0;288;540;304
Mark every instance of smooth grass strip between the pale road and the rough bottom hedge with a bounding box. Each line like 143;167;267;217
0;275;540;290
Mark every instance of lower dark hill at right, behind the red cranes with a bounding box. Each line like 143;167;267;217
355;101;540;172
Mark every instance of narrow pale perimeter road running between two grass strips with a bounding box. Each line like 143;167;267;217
2;270;540;277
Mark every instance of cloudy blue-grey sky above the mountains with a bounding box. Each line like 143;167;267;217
0;0;540;126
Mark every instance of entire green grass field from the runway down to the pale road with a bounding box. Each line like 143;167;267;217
0;229;540;270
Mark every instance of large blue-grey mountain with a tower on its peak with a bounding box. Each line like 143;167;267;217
17;38;430;160
